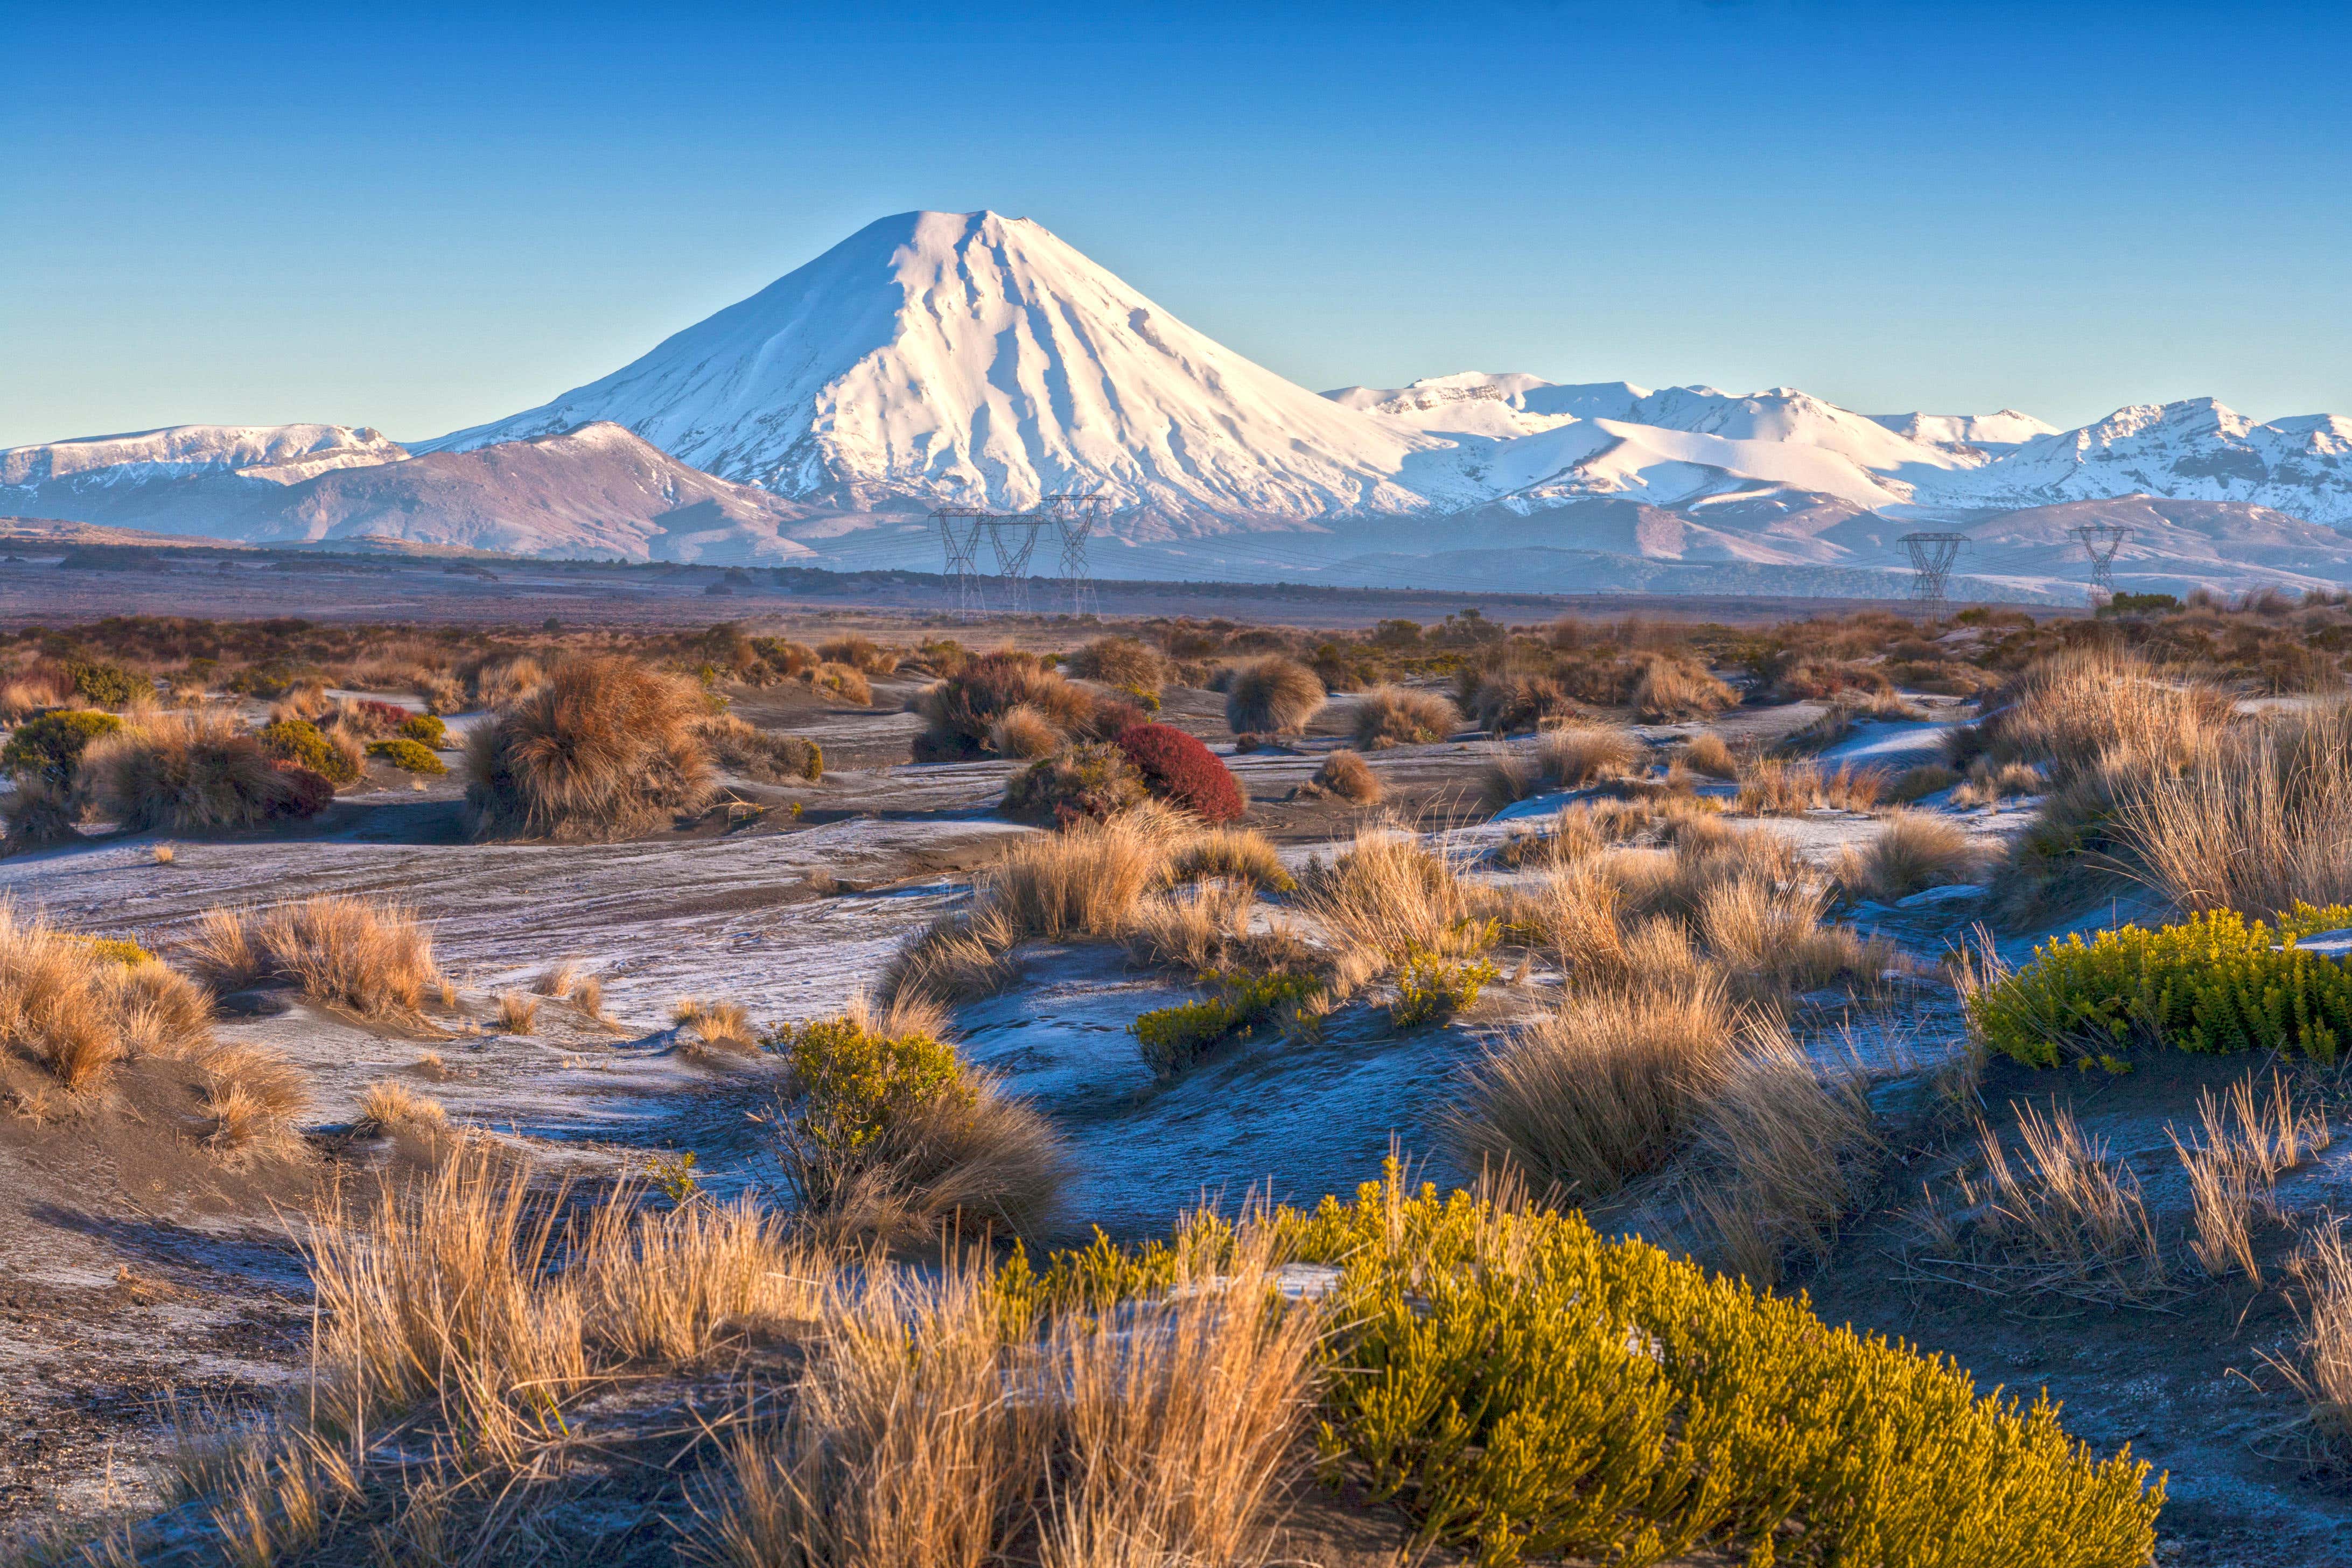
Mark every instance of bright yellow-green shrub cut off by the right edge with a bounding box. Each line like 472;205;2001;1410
1969;905;2352;1067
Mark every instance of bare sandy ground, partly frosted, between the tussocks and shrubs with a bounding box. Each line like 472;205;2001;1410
0;682;2352;1566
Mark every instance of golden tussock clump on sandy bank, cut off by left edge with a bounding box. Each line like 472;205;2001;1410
0;902;212;1095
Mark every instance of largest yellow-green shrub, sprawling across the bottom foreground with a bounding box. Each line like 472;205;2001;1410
997;1164;2164;1568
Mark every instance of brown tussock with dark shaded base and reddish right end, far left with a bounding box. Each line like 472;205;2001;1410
78;708;334;832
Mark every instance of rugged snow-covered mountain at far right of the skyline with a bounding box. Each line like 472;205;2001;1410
1924;397;2352;527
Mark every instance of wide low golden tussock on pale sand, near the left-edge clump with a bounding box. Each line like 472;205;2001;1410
188;893;440;1018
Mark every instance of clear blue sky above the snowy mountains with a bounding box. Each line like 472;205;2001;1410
0;0;2352;444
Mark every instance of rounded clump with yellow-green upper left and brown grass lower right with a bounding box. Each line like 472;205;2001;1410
772;1004;1066;1241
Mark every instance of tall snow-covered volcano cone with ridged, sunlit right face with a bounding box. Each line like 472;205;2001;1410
419;212;1442;517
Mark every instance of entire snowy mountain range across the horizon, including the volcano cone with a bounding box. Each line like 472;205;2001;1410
0;212;2352;597
